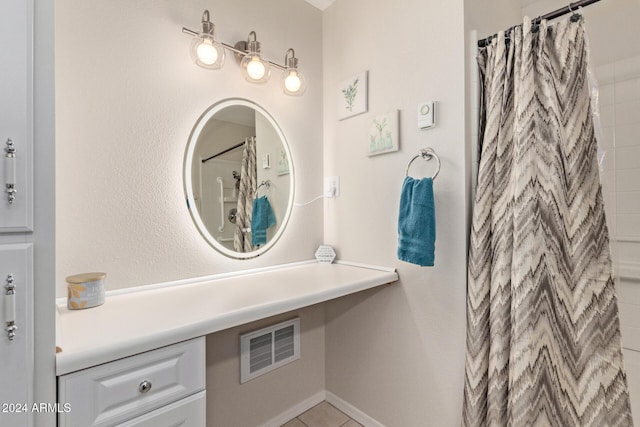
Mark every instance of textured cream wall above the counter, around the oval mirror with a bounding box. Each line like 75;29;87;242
55;0;323;297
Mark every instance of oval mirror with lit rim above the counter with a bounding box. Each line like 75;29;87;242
184;99;294;259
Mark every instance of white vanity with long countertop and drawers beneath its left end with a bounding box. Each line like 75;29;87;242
56;261;398;427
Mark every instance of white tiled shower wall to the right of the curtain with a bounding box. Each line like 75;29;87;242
594;46;640;427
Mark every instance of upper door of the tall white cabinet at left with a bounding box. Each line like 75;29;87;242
0;1;33;232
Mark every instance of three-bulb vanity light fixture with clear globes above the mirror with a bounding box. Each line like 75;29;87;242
182;10;307;96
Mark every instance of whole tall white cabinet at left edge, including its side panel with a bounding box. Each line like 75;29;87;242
0;0;56;427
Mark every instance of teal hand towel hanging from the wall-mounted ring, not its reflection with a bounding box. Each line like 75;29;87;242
398;176;436;267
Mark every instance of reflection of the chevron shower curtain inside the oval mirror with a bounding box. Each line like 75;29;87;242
233;137;258;252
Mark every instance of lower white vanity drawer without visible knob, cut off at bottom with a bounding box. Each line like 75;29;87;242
118;391;206;427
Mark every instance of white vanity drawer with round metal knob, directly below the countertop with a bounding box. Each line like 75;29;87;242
58;337;205;427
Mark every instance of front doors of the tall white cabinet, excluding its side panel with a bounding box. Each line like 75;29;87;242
0;1;33;426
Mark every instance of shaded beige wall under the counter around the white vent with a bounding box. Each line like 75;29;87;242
206;304;325;427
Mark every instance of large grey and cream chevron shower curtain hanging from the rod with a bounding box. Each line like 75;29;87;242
463;18;632;427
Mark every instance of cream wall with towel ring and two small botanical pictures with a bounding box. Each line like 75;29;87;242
323;0;468;426
